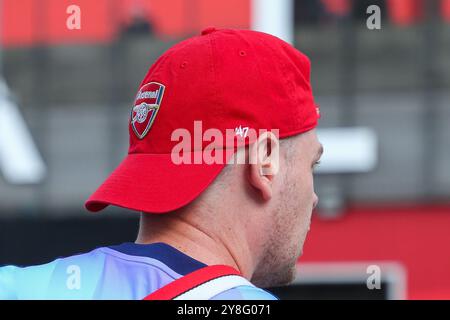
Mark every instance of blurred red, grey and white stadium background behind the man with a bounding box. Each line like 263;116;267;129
0;0;450;299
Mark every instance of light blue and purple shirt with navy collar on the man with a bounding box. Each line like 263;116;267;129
0;243;277;300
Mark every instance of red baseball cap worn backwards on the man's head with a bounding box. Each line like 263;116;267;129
85;28;319;213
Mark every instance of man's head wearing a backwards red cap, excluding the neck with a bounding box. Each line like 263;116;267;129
86;28;319;285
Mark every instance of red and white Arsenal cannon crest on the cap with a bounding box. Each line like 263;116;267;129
131;82;165;139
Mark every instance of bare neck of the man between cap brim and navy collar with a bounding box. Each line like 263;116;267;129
136;212;254;280
